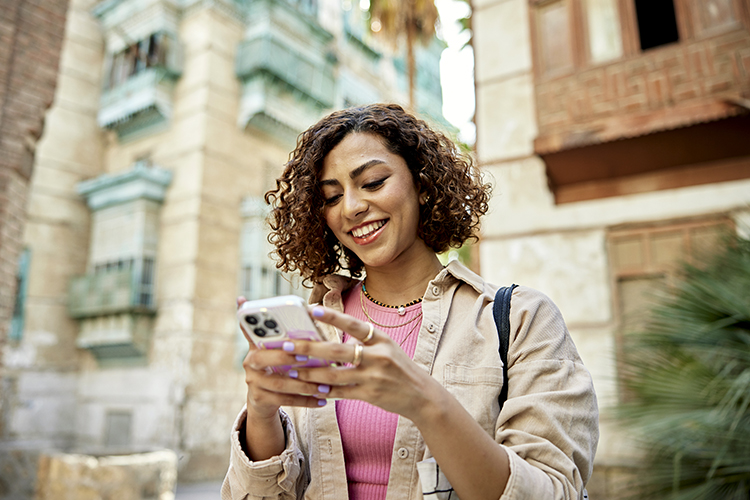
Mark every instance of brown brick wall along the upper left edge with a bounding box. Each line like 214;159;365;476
0;0;68;360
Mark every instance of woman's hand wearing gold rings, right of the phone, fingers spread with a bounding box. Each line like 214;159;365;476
286;306;442;421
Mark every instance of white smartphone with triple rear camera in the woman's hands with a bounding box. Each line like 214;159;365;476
237;295;334;373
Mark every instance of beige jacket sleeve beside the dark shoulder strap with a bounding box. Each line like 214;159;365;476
495;287;599;500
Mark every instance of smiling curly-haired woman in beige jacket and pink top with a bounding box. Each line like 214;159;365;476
222;105;598;500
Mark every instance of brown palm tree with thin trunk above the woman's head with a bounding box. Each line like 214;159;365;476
370;0;438;109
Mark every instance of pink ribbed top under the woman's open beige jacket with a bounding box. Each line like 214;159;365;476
336;286;422;500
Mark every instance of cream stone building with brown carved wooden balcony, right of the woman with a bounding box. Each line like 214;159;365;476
473;0;750;499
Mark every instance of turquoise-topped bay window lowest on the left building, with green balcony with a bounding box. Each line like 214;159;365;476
68;160;172;360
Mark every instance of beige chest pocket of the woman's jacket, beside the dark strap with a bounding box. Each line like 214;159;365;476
443;364;503;437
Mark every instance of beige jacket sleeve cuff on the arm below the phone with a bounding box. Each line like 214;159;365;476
221;408;309;500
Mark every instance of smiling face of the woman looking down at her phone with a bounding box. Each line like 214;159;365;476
320;133;434;268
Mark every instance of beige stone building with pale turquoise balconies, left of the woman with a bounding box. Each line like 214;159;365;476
0;0;442;498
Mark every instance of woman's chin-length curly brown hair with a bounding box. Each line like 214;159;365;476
265;104;490;282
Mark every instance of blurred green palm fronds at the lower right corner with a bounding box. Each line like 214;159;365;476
618;238;750;500
